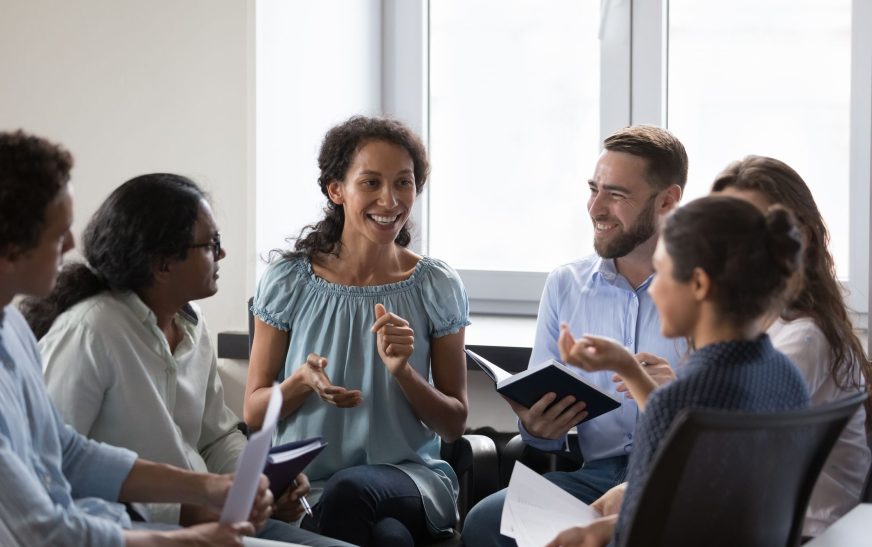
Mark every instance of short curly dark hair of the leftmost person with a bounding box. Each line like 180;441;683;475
0;130;73;254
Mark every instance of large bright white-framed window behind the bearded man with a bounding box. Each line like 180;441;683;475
412;0;872;313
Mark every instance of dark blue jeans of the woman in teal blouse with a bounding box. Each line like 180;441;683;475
303;465;430;547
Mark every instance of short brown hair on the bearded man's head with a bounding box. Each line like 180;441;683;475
603;125;688;191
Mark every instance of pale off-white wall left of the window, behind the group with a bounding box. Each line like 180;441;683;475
0;0;516;429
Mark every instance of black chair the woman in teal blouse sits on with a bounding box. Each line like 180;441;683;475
249;298;500;547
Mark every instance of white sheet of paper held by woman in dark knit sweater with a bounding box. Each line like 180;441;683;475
500;462;600;547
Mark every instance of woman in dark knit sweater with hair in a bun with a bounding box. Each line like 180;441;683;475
549;197;809;547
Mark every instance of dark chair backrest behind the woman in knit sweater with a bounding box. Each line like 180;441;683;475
621;392;866;547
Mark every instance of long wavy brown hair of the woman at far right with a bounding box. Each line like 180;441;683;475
712;156;872;418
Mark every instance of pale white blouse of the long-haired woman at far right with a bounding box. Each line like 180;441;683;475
768;317;872;536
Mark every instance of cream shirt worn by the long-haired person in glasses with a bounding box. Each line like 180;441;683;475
39;292;246;523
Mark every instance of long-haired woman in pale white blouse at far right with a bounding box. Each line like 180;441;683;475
712;156;872;536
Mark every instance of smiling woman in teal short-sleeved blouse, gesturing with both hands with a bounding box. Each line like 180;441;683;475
245;117;469;546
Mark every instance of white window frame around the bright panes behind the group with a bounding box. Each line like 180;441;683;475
382;0;872;322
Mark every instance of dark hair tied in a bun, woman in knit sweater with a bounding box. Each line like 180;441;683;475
662;196;803;334
